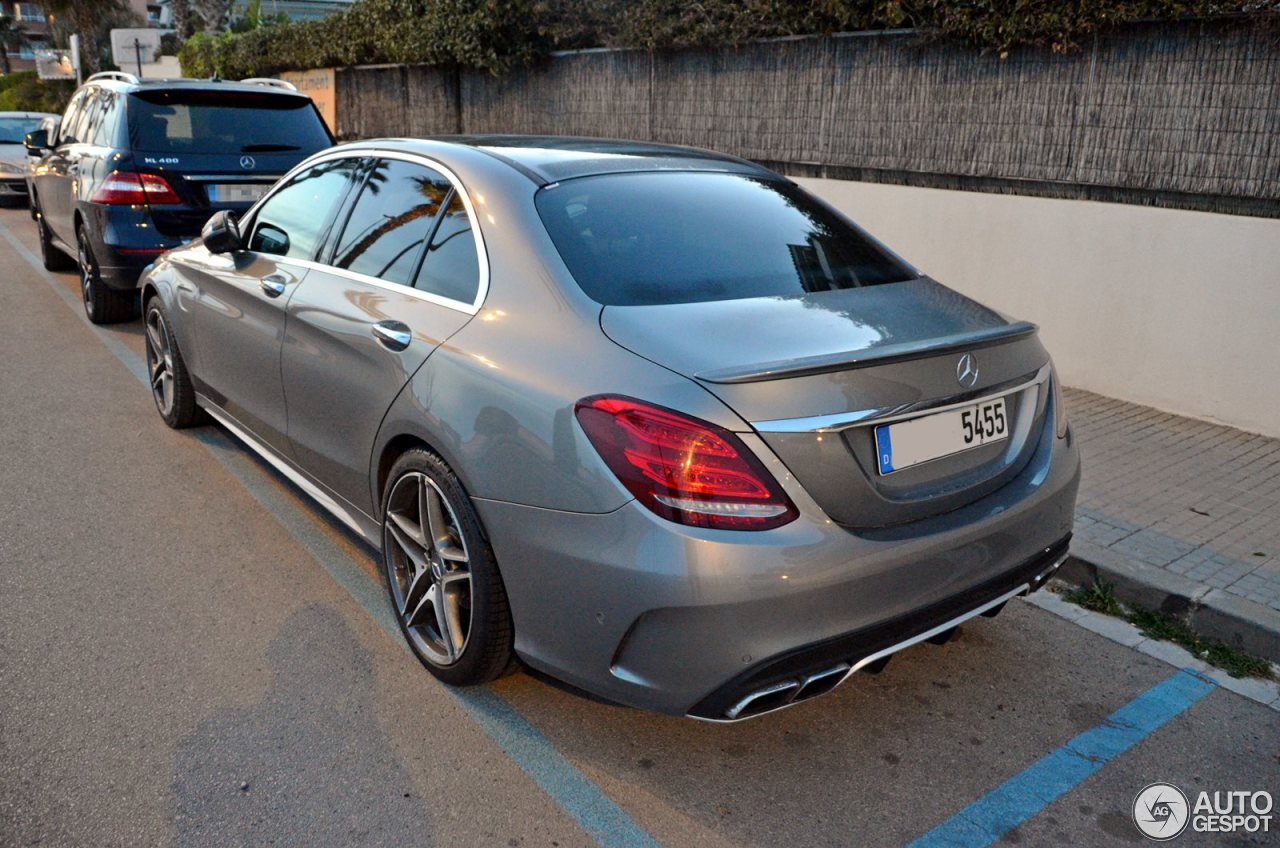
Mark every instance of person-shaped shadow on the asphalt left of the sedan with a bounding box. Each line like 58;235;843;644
173;606;431;845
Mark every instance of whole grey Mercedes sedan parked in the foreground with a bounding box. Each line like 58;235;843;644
140;136;1079;721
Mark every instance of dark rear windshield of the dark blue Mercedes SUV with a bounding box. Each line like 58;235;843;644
128;90;333;154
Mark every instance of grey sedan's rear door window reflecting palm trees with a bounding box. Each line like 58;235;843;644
333;159;452;286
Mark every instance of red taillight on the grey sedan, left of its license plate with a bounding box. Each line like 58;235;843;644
575;397;799;530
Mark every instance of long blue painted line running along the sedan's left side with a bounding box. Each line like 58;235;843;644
0;224;659;848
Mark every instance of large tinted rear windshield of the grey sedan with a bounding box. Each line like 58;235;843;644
536;172;915;306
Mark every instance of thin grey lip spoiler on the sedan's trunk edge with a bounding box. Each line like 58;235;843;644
694;322;1039;384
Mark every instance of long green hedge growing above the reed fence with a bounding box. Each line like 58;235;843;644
179;0;1280;78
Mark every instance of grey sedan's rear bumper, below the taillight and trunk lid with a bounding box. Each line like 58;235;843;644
477;415;1079;720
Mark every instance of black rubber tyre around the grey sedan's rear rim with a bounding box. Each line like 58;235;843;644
383;448;516;687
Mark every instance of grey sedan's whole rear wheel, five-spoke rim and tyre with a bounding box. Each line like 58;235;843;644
383;450;515;685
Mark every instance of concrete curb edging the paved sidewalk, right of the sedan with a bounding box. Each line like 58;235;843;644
1053;539;1280;662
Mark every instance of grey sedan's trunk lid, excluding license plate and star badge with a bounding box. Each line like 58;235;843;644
600;278;1048;526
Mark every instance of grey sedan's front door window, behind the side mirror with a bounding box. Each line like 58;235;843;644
248;159;361;259
